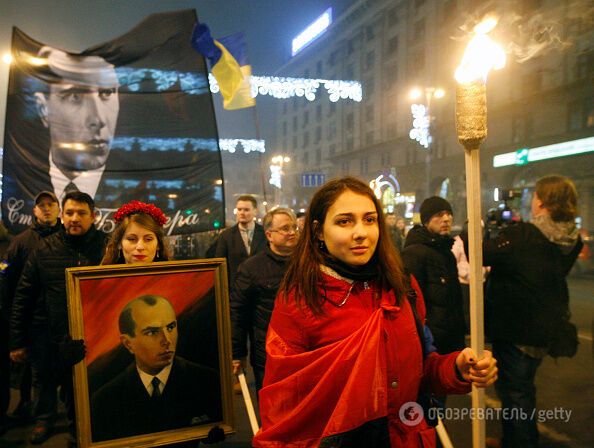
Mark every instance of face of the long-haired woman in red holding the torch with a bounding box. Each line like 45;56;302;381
318;190;379;266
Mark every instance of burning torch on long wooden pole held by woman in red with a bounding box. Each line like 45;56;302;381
455;18;505;448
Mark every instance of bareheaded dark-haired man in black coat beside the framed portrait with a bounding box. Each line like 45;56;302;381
10;191;105;443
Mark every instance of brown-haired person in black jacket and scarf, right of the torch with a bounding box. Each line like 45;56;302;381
483;176;583;448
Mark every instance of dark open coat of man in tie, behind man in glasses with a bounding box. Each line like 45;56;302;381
215;224;266;286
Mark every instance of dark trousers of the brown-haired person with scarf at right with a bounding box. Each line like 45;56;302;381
493;341;542;448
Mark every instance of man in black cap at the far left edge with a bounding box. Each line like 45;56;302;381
0;191;60;430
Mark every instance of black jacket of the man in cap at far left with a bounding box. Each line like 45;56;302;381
4;220;62;310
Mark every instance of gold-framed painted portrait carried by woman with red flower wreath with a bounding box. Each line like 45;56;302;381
66;259;234;448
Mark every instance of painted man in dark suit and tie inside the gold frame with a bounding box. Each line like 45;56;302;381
91;295;222;442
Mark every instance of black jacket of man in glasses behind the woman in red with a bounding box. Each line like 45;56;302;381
230;247;290;369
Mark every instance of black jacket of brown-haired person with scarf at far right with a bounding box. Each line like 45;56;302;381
483;223;583;347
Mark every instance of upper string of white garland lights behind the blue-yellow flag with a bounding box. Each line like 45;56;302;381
208;73;363;103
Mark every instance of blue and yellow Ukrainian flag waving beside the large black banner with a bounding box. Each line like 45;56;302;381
192;23;256;110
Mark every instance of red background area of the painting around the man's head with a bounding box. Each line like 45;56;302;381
80;272;215;365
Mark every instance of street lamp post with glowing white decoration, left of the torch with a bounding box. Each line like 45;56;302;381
409;87;445;197
